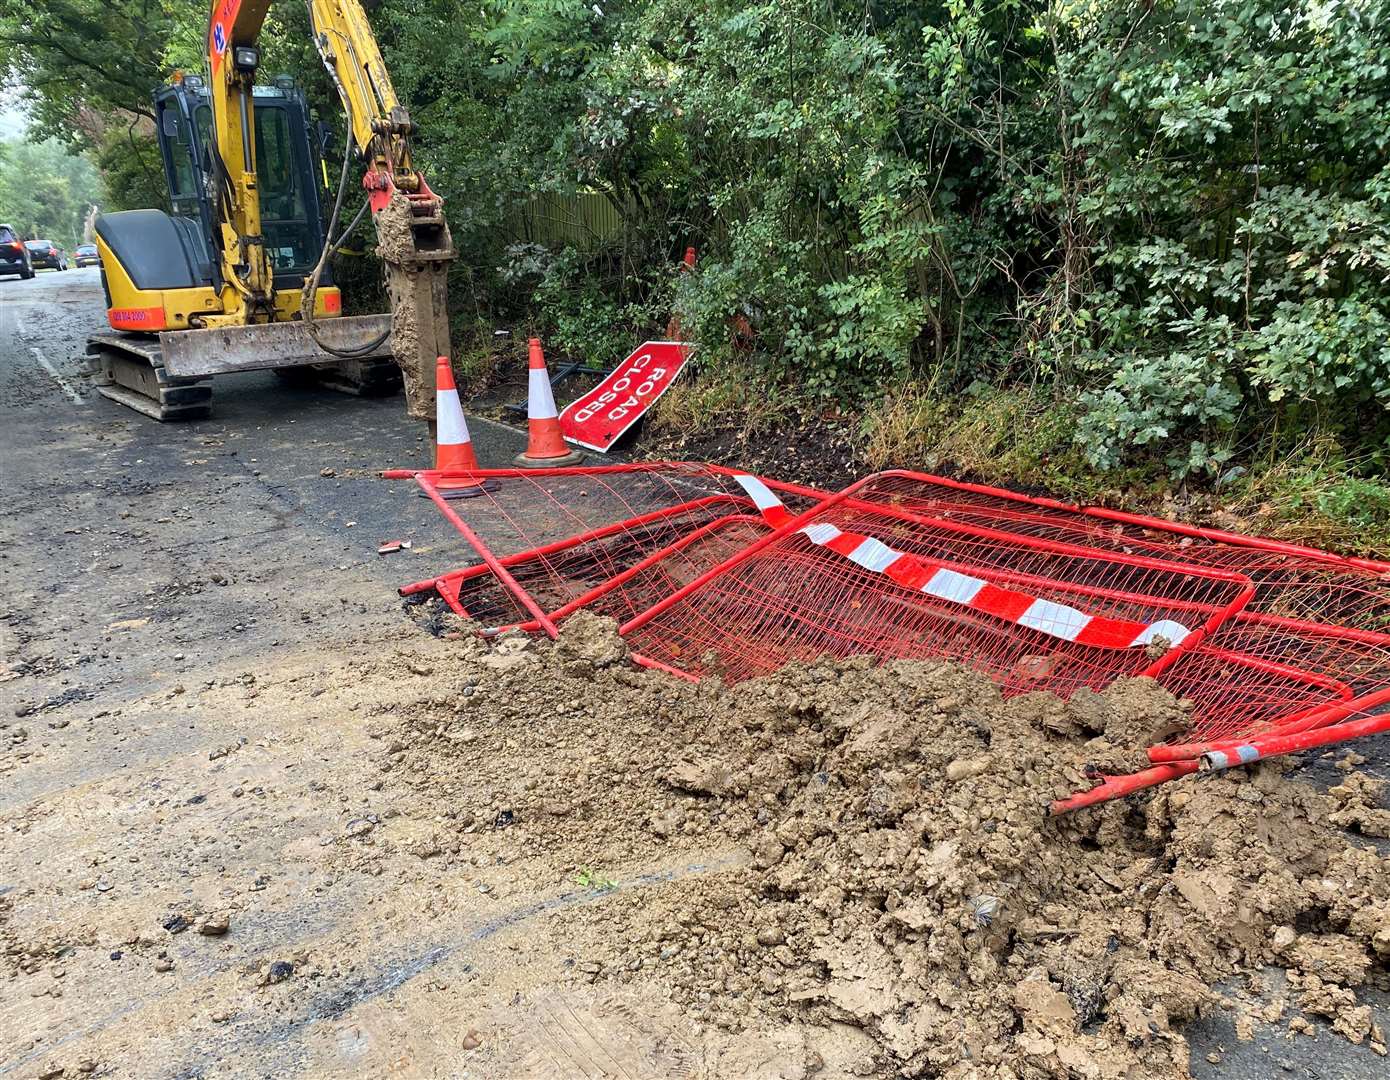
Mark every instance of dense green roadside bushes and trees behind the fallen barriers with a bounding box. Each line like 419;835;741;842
8;0;1390;547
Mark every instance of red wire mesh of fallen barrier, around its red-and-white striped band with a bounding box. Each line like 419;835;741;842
624;505;1250;695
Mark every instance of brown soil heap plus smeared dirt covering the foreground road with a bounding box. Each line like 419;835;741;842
0;603;1390;1080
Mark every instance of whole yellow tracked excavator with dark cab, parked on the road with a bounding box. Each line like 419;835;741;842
88;0;455;420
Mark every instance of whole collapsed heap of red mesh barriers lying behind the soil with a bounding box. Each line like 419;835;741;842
392;463;1390;810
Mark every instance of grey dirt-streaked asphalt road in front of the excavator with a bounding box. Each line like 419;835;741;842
0;268;524;739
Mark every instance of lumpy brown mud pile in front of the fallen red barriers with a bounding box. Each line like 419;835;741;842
377;613;1390;1080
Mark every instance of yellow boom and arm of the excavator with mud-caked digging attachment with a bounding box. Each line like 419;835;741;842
206;0;455;420
